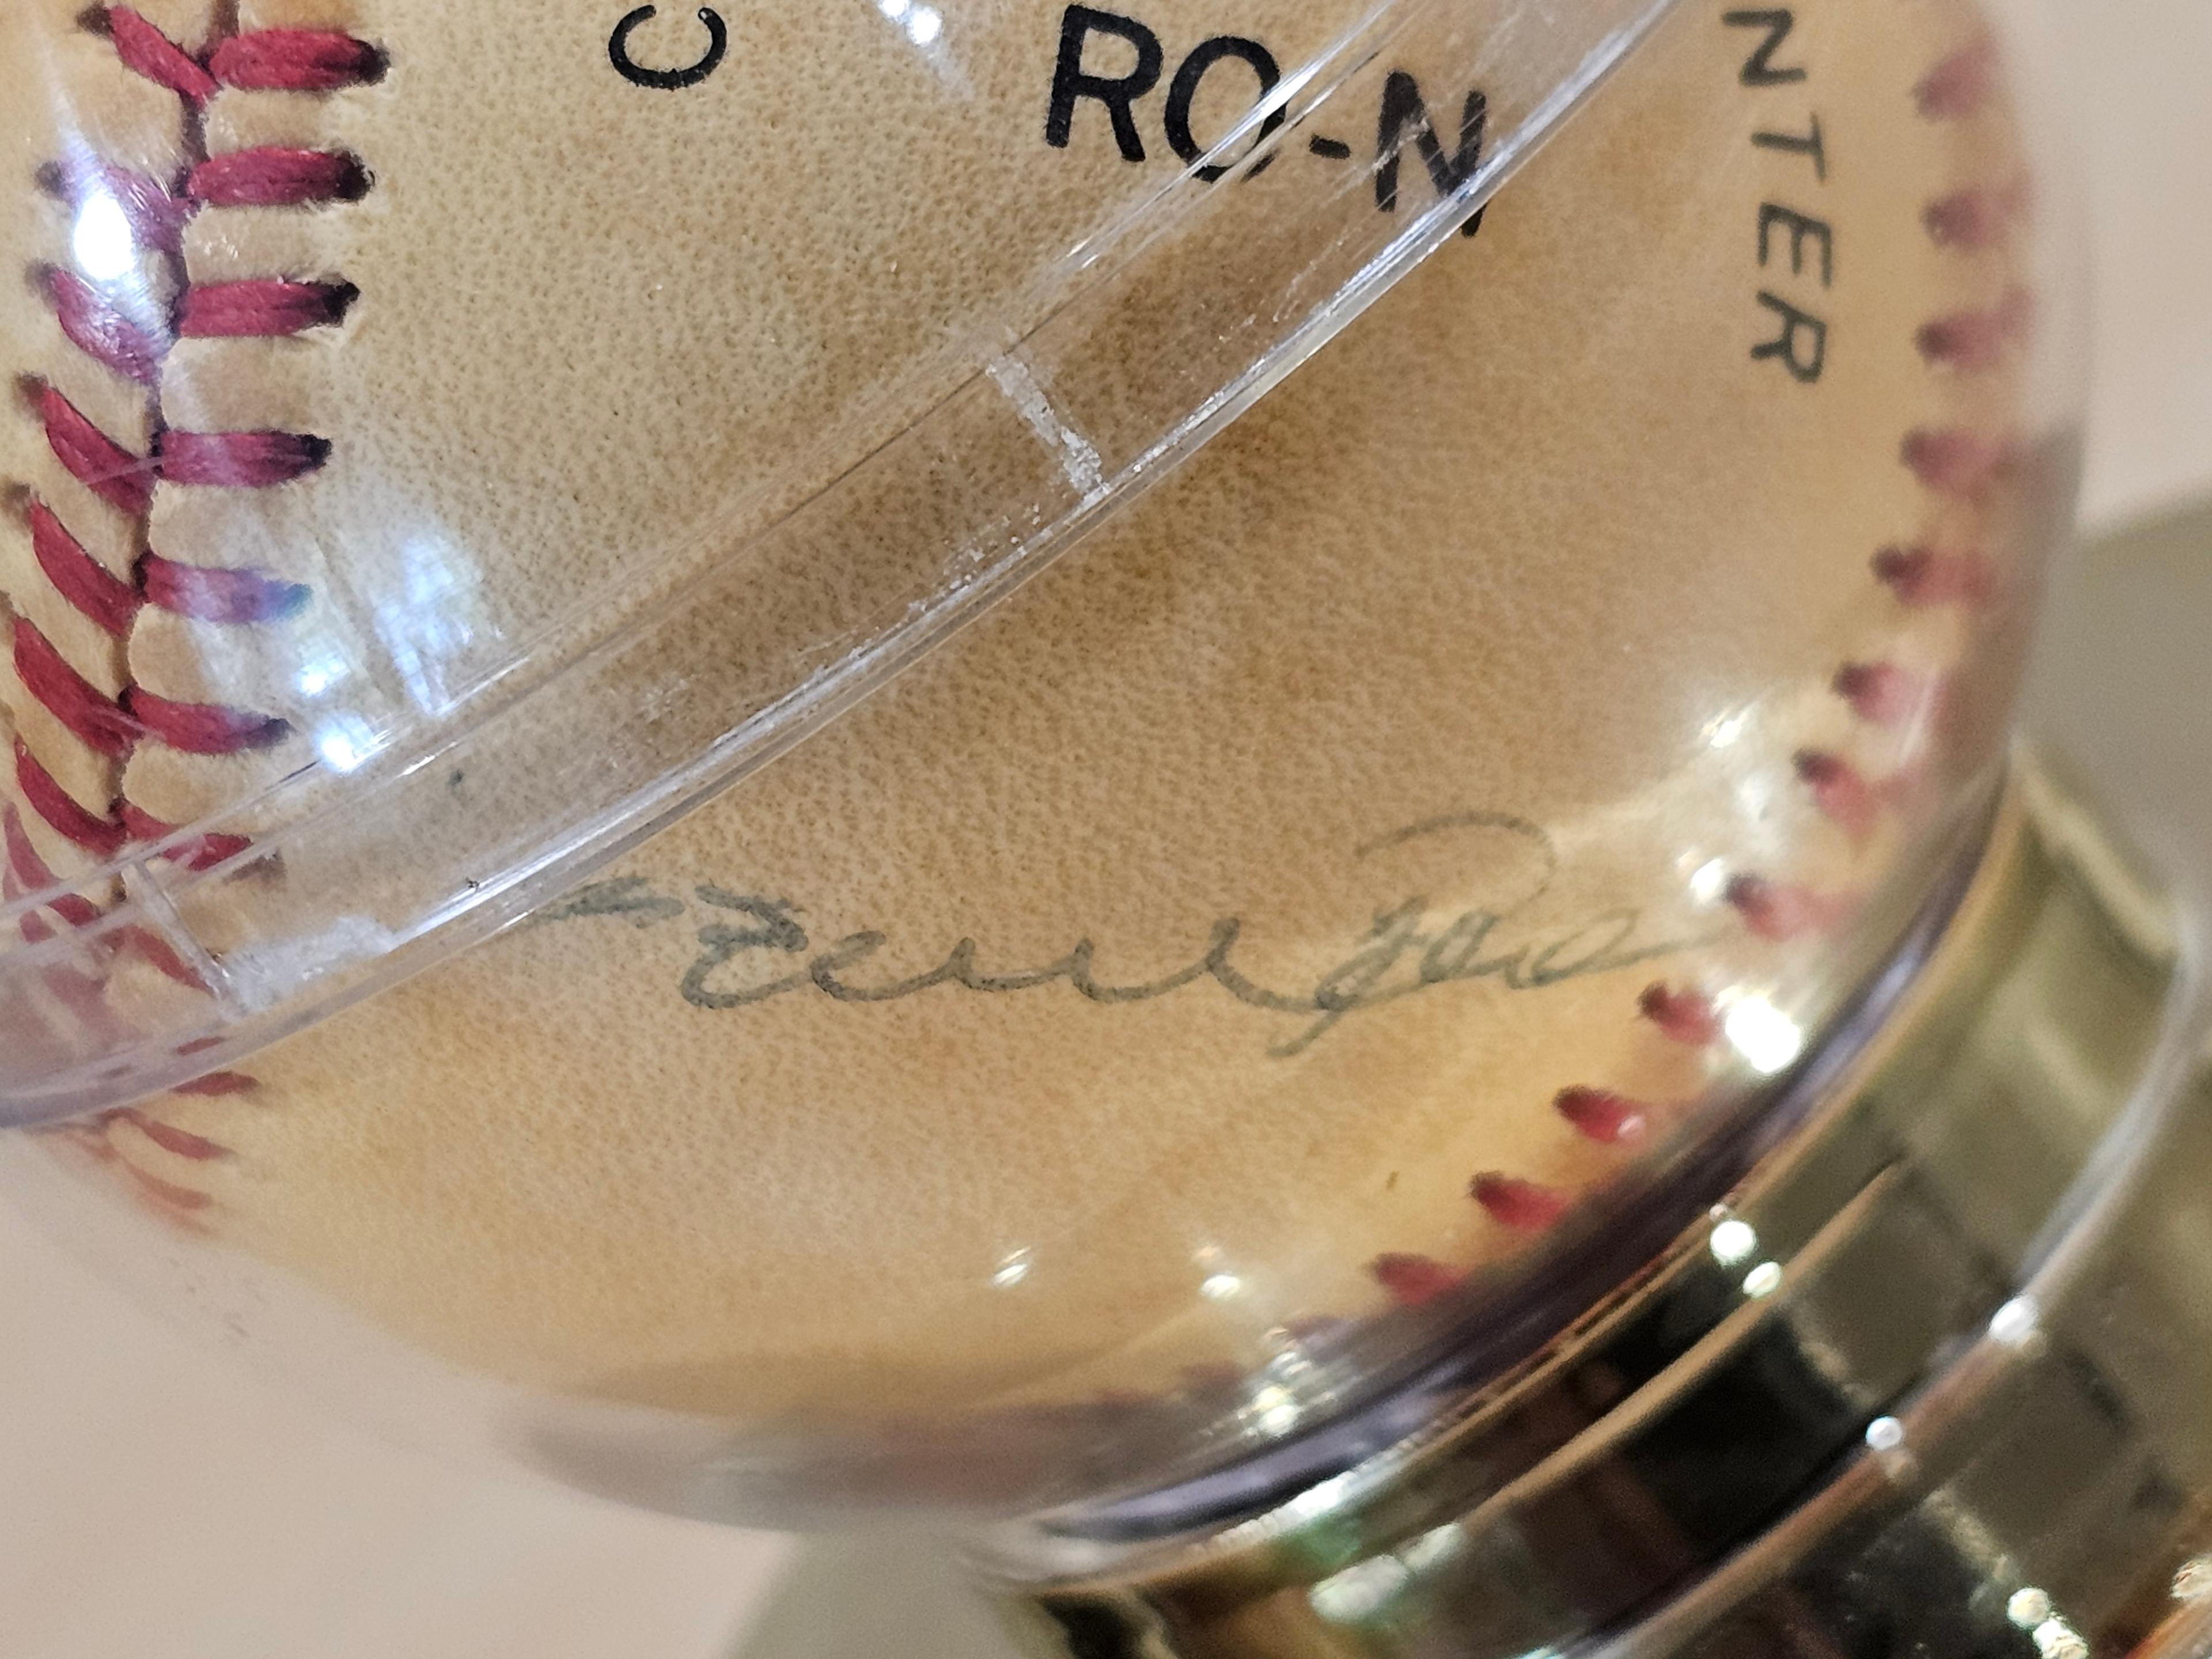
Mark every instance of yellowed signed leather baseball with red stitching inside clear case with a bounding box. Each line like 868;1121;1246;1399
0;0;2044;1504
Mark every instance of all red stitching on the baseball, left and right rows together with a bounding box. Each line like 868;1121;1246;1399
26;7;2033;1274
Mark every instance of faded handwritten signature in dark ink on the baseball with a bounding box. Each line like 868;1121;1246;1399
533;812;1714;1059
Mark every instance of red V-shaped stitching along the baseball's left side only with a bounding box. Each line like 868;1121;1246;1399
14;7;387;1219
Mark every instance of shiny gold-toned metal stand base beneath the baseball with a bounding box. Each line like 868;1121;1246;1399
1006;766;2212;1659
